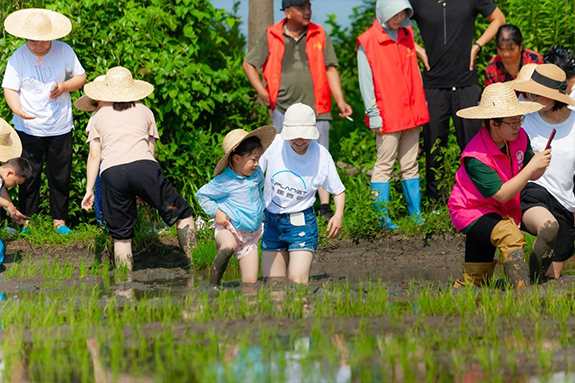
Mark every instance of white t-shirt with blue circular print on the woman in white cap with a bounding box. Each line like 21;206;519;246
260;134;345;214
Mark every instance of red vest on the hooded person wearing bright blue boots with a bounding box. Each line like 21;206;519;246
357;20;429;133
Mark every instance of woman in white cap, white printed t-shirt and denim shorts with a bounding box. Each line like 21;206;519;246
260;103;345;283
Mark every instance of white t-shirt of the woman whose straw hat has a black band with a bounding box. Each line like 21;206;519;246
523;111;575;212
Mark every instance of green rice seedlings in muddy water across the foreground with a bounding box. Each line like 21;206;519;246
2;267;575;382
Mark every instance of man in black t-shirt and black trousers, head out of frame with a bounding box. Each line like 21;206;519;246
410;0;505;200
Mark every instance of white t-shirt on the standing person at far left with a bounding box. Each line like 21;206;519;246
2;40;84;137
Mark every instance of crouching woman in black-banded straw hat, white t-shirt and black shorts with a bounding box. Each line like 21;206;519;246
512;64;575;281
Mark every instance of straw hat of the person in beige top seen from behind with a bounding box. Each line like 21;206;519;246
84;66;154;102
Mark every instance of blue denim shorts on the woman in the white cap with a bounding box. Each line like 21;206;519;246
262;207;318;253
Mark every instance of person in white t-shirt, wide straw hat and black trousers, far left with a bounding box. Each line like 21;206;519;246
2;8;86;234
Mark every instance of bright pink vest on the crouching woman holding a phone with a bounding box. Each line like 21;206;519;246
447;127;527;231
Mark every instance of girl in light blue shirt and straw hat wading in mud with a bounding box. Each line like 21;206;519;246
196;126;276;286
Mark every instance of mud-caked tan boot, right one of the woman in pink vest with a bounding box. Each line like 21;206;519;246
491;217;531;289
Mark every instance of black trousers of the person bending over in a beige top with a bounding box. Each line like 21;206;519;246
101;160;194;239
